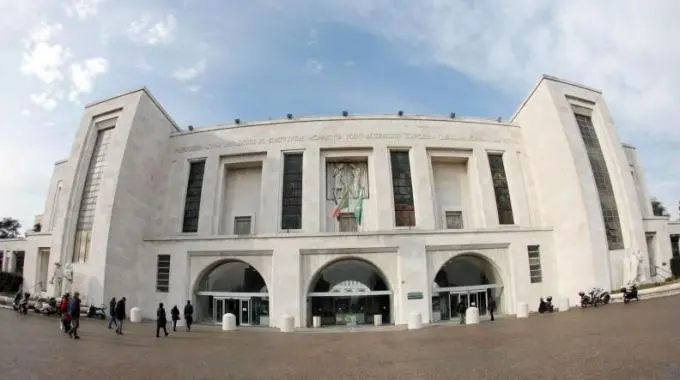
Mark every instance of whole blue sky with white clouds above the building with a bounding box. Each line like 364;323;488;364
0;0;680;226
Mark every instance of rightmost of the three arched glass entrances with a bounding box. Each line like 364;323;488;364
432;254;503;322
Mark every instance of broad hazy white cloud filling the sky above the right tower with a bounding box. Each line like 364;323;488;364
294;0;680;217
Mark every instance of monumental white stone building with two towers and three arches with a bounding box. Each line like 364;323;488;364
0;76;680;326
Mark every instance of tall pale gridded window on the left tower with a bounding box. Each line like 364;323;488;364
72;128;114;263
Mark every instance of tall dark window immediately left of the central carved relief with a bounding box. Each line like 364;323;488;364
281;153;302;230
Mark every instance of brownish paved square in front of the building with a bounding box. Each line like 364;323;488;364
0;296;680;380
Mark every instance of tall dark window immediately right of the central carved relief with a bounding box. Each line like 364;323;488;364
390;150;416;227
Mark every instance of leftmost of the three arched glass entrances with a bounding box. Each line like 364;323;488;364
196;261;269;326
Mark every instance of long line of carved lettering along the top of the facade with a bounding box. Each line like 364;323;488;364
175;132;474;153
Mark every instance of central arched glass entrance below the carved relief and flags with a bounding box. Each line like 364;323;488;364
307;258;392;326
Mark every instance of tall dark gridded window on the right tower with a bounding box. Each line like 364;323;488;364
574;113;624;250
